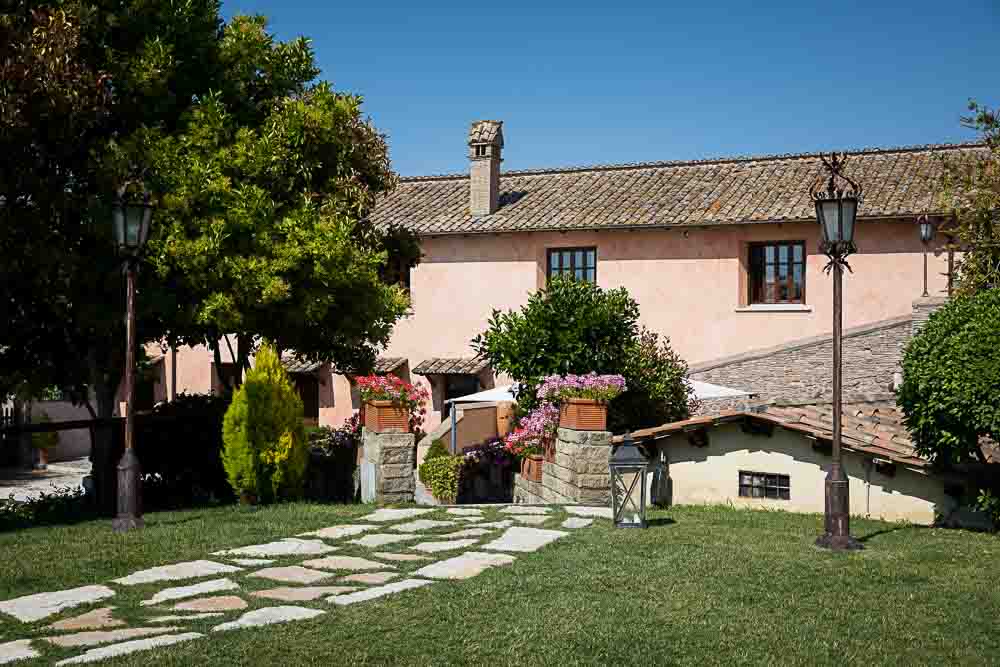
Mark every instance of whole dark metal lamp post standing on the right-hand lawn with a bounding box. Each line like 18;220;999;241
809;153;862;551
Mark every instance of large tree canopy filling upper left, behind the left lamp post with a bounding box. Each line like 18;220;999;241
0;0;418;404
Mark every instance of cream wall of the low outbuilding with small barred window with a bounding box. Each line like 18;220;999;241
660;424;954;524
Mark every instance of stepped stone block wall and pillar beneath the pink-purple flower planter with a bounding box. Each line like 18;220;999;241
514;428;611;505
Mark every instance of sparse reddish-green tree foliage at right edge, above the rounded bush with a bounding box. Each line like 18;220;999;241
941;101;1000;295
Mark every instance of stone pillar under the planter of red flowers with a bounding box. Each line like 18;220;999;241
361;428;416;505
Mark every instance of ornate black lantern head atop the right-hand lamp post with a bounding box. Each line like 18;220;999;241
810;153;861;259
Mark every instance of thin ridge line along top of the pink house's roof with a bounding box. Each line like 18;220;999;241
399;141;986;183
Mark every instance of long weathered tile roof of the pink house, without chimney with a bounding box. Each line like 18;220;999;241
372;142;983;235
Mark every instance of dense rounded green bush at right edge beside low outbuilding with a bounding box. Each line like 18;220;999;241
897;289;1000;463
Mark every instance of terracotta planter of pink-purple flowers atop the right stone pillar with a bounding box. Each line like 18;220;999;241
538;373;625;431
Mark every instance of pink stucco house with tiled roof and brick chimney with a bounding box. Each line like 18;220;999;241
157;121;980;436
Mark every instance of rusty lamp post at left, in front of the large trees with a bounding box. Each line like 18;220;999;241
111;187;153;533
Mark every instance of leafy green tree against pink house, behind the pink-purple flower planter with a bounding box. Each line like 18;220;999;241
472;278;691;432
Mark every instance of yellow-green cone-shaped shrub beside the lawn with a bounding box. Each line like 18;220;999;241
222;343;309;503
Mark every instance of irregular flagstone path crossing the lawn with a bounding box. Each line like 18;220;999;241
0;505;611;665
